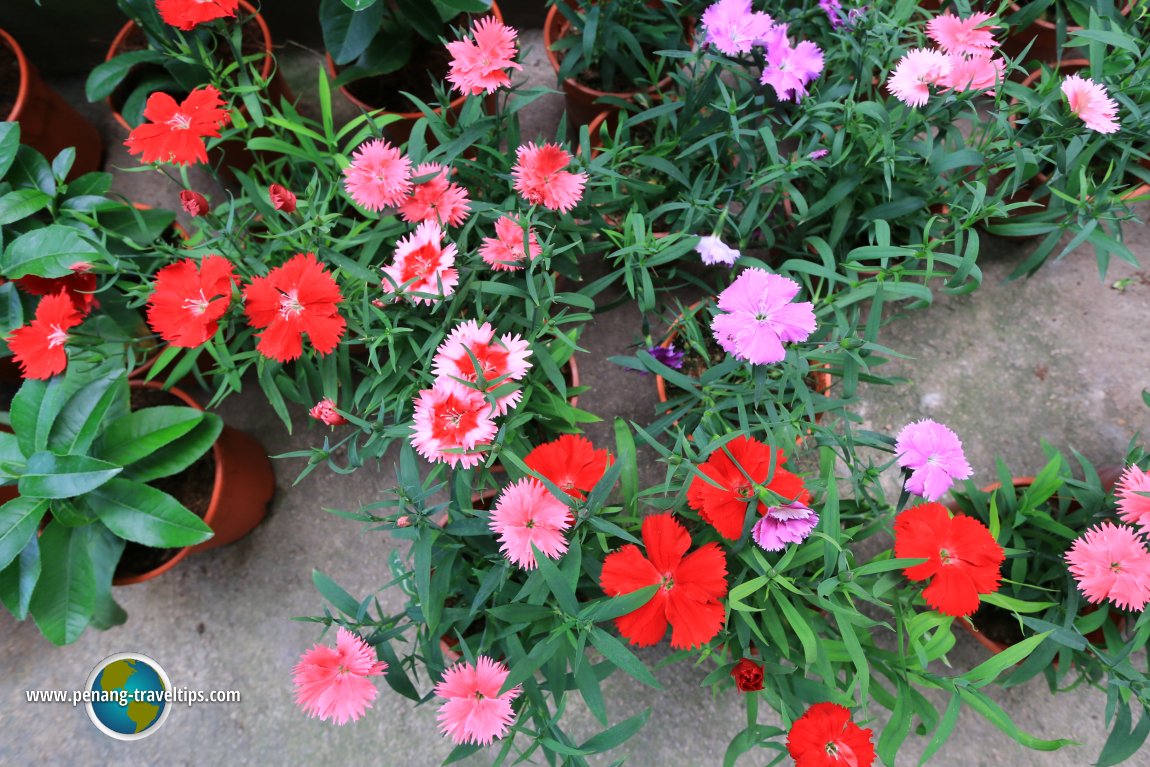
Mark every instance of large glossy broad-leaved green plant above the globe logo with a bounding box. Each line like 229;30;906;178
0;361;222;645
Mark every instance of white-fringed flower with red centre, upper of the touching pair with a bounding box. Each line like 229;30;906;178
431;320;531;415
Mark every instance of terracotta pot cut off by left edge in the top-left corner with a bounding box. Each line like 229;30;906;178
0;30;104;178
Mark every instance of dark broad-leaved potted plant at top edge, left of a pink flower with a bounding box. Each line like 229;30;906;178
320;0;503;144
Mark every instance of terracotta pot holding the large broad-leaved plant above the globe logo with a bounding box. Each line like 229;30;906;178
113;381;276;585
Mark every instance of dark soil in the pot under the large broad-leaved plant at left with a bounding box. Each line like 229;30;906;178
115;388;216;578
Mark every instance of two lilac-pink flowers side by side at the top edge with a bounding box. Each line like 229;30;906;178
703;0;823;101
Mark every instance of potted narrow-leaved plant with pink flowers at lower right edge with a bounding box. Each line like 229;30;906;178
951;445;1150;764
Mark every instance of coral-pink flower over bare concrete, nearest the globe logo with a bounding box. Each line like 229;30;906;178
292;627;388;724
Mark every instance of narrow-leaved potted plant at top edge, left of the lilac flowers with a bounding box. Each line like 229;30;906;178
543;0;692;125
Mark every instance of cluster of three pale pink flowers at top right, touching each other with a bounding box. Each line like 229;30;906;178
887;11;1006;107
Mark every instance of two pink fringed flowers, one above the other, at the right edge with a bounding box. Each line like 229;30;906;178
1066;465;1150;611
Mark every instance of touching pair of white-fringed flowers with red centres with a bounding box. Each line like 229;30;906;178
412;320;531;468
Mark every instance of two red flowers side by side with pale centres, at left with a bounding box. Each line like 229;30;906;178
147;253;346;362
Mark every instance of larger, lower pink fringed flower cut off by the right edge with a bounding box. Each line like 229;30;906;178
1066;522;1150;611
